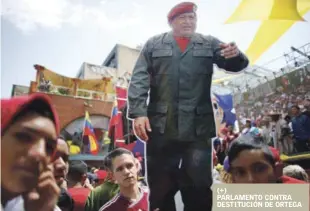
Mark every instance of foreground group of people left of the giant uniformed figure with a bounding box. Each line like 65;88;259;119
1;93;148;211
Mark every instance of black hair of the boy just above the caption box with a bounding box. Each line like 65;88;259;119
228;135;276;167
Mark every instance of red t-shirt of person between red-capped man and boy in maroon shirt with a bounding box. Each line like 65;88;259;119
68;188;90;211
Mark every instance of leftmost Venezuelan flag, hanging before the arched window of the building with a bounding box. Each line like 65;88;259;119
83;111;99;155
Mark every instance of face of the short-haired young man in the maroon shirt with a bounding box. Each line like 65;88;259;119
112;154;138;187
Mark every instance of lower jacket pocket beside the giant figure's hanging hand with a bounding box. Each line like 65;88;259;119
148;104;168;134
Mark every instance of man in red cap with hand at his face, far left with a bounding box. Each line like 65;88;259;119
1;94;60;211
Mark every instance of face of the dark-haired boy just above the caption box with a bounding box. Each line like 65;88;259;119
230;149;276;183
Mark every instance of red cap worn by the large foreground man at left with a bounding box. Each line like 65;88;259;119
1;93;60;136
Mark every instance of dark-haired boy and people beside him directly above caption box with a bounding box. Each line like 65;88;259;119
213;134;309;184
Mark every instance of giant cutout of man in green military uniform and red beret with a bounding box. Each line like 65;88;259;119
128;2;249;211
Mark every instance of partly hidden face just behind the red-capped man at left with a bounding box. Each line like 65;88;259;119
53;139;69;186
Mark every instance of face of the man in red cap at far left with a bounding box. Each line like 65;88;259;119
1;113;57;194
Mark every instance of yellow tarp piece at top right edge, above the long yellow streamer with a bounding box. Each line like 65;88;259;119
226;0;304;23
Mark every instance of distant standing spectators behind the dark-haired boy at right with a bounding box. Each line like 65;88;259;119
213;105;310;166
